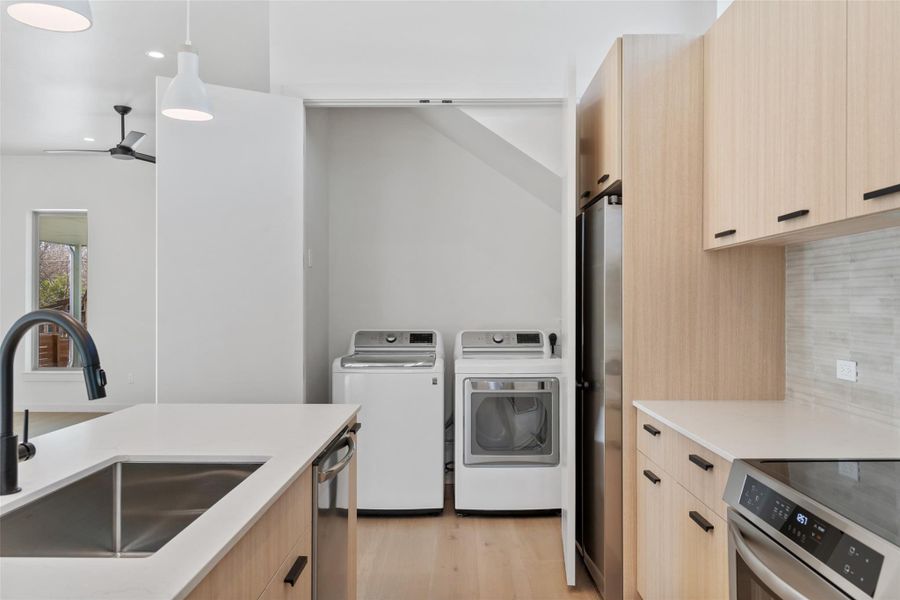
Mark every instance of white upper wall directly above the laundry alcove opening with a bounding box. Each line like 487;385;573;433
269;0;717;98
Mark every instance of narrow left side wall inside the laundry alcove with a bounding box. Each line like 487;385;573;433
303;108;331;403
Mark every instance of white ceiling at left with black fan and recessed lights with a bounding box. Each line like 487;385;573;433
0;0;269;155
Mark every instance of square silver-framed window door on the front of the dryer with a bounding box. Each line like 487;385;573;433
464;378;559;467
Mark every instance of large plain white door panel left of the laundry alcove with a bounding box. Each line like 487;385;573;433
156;78;303;402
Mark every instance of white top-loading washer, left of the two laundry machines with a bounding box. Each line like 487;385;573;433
331;330;445;514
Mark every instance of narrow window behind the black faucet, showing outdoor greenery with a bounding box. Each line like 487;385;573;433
34;211;88;369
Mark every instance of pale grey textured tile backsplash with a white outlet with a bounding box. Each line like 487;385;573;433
785;227;900;426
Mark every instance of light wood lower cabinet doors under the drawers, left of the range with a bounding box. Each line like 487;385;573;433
637;452;728;600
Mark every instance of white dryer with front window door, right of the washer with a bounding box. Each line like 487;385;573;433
454;331;562;513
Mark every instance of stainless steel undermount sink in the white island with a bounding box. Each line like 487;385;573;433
0;461;263;558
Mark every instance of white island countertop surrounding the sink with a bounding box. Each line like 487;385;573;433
0;404;359;600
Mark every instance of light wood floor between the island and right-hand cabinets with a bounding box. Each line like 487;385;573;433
357;486;600;600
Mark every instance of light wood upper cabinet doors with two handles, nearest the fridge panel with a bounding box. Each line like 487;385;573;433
704;0;852;248
